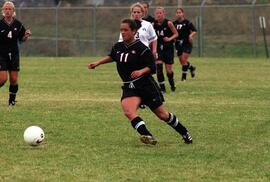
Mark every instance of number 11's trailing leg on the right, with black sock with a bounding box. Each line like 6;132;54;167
152;105;192;144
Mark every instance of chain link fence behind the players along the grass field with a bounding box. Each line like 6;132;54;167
16;4;270;57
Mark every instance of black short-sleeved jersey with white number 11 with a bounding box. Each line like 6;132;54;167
109;40;156;82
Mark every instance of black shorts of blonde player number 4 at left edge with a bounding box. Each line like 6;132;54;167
0;53;20;71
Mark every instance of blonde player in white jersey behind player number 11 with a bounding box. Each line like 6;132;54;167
119;3;157;57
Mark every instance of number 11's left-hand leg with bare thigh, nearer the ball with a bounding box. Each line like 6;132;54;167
121;96;157;145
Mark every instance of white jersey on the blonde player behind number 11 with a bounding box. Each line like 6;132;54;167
118;20;157;47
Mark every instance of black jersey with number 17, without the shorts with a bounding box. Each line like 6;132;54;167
173;19;197;44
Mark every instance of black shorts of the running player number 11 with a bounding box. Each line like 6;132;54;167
121;76;164;110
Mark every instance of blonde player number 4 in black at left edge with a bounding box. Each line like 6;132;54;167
0;1;31;106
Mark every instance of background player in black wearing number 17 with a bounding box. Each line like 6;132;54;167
173;8;197;81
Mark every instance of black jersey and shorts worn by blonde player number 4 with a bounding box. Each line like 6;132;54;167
0;19;26;71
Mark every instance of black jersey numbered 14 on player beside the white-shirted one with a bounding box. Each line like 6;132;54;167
154;19;173;50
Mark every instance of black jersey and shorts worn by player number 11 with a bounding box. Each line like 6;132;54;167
109;40;164;110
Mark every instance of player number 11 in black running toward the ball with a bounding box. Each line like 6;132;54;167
88;19;192;145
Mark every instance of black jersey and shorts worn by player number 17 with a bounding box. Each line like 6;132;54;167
173;19;197;56
